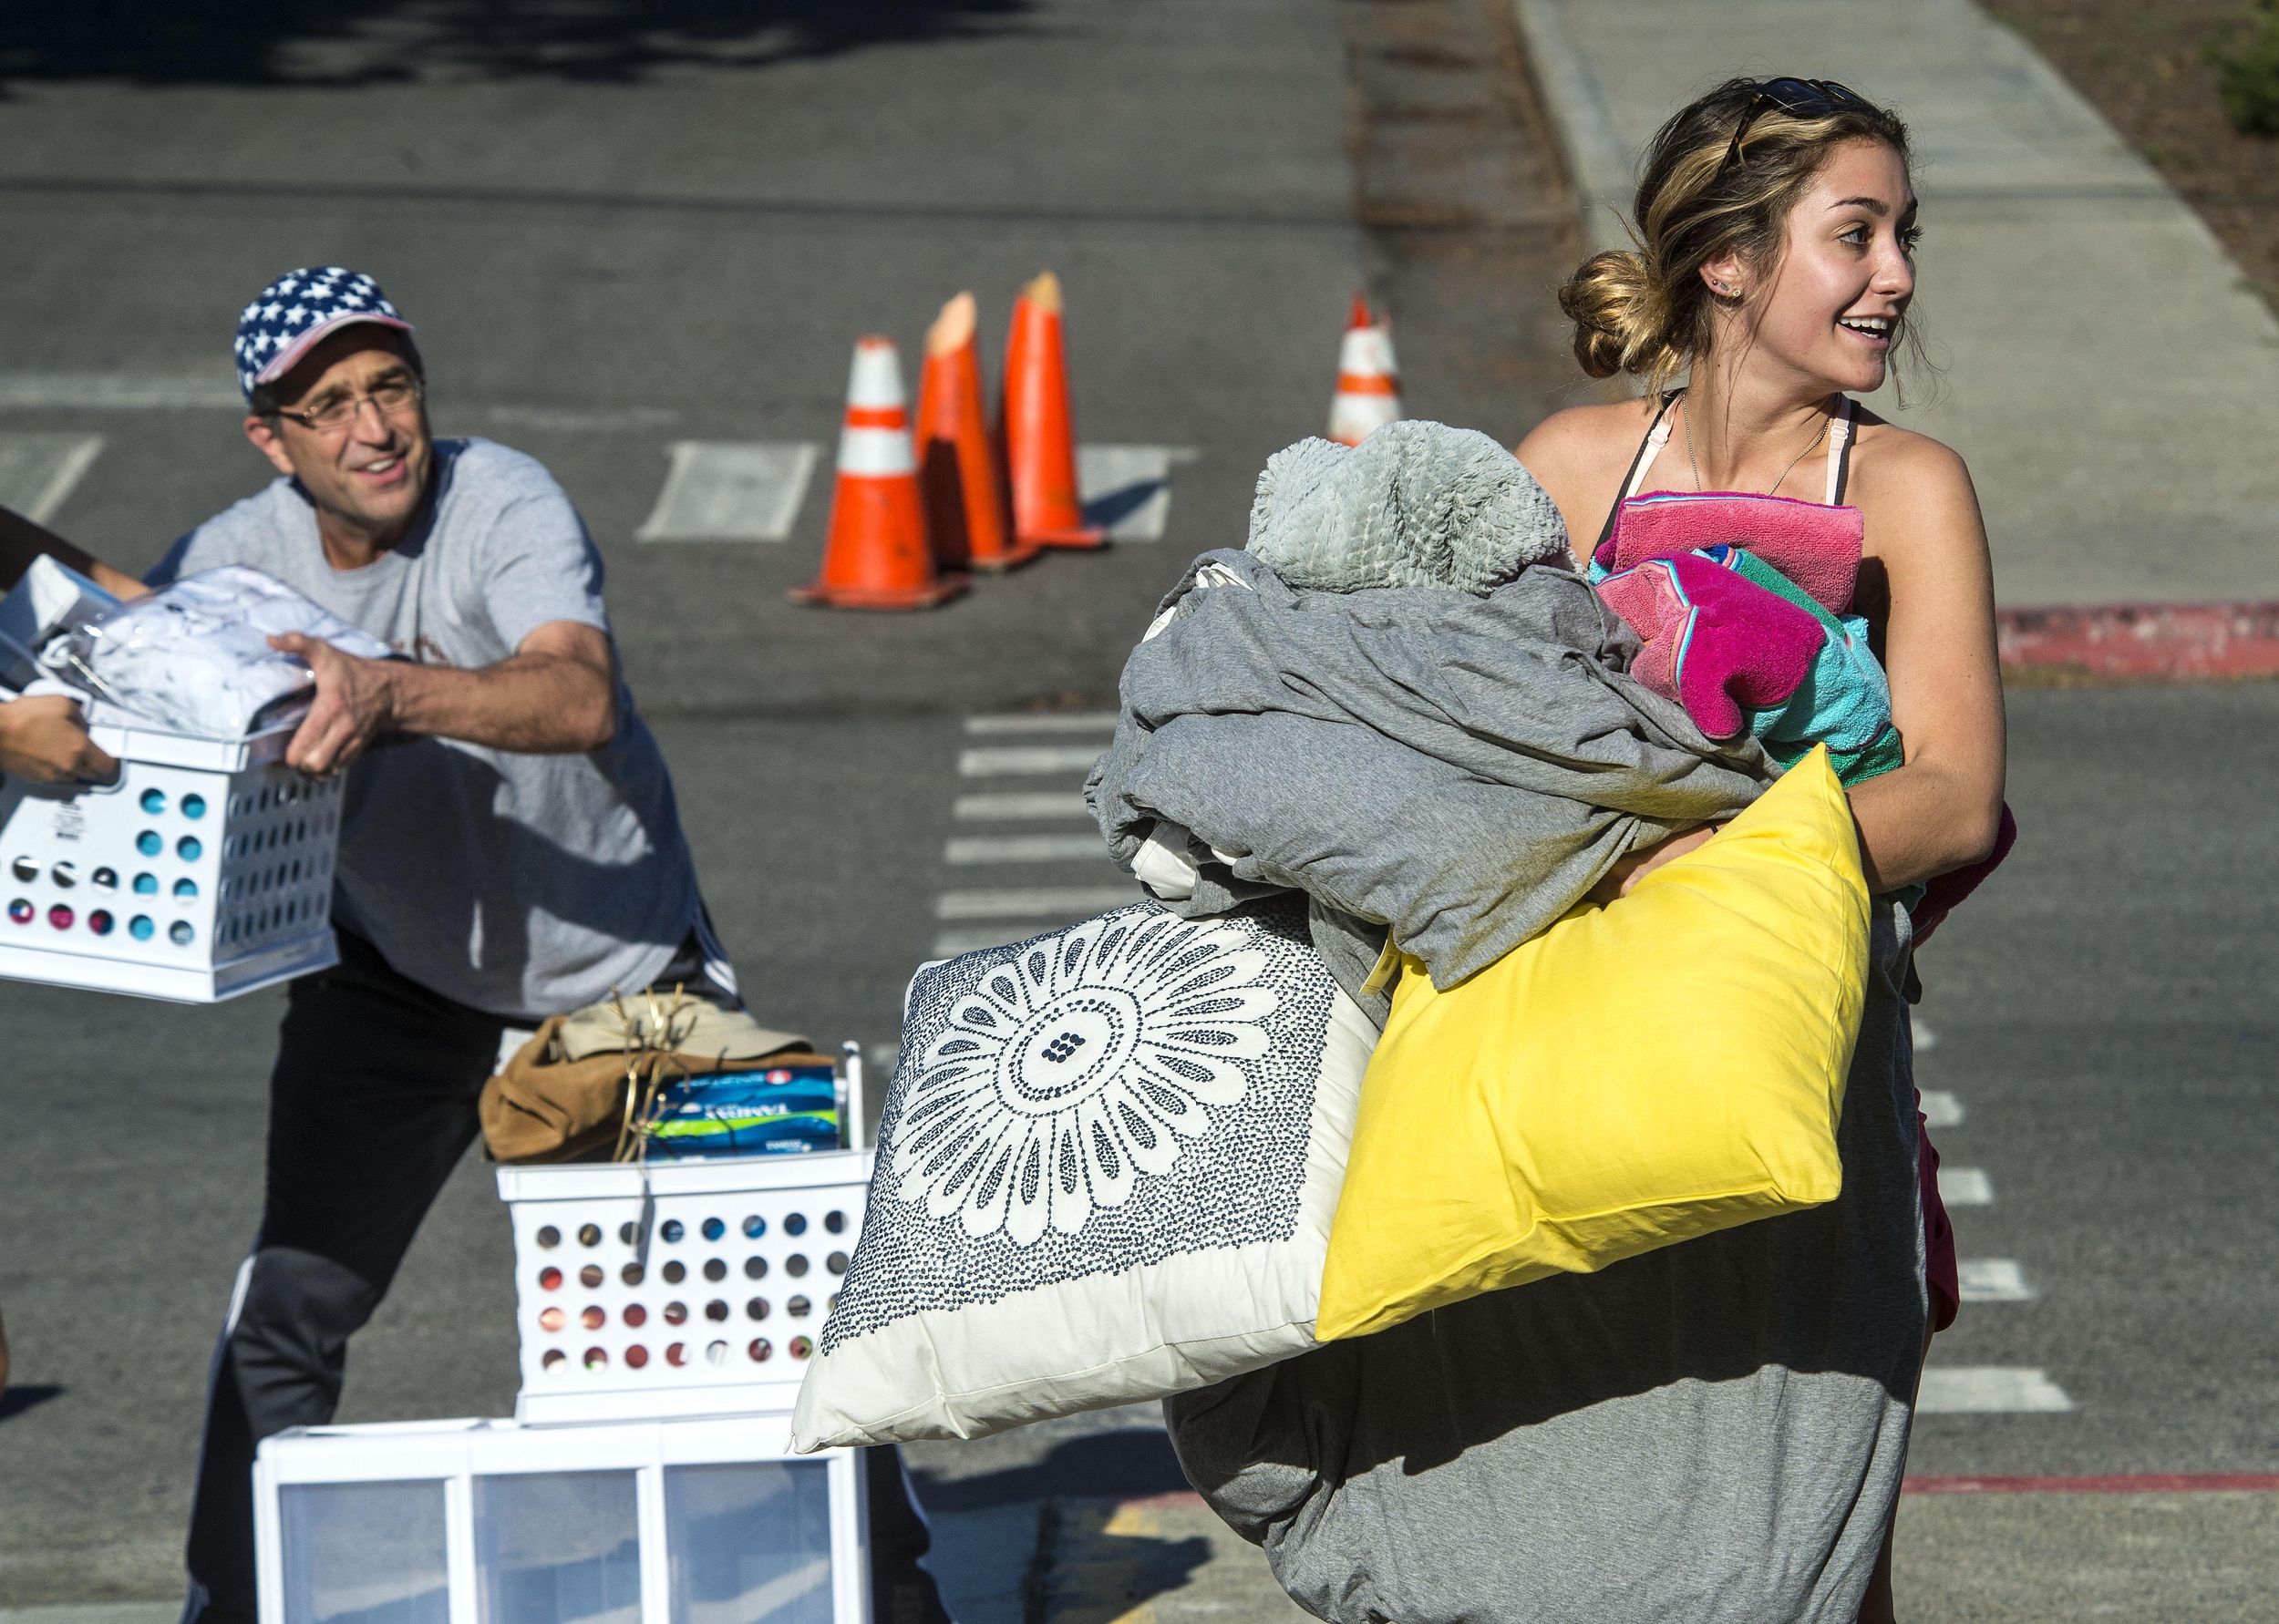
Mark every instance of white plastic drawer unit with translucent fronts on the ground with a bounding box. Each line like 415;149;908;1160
253;1414;871;1624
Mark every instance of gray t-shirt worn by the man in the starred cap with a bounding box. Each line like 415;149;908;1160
149;439;697;1021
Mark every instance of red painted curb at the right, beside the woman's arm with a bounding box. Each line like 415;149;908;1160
1995;603;2279;679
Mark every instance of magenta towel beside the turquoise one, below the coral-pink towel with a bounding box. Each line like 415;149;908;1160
1598;553;1823;738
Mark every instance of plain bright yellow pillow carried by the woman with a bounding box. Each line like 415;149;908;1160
1315;749;1869;1341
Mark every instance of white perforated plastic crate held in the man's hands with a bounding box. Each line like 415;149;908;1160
0;726;340;1004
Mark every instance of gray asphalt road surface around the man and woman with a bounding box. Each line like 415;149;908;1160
0;0;2279;1624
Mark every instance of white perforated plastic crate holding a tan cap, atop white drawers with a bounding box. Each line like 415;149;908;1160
500;1138;873;1422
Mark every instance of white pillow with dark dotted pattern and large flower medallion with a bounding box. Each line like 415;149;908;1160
793;899;1377;1449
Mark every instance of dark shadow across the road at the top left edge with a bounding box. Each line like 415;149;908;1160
0;0;1035;93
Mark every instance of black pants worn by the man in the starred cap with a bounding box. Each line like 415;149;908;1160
182;934;948;1624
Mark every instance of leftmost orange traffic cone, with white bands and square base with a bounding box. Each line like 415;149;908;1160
791;337;966;608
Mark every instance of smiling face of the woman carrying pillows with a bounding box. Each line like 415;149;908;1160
1741;141;1917;394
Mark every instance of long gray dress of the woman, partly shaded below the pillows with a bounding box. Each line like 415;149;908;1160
1165;898;1926;1624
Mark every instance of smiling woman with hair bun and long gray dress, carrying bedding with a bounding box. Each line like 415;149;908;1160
1167;79;2004;1624
